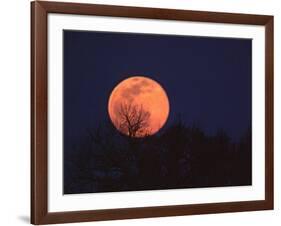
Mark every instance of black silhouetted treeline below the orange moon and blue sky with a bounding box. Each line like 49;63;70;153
64;120;252;194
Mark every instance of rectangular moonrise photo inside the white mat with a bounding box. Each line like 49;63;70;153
62;29;252;195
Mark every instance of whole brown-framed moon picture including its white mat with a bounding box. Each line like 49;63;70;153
31;1;273;224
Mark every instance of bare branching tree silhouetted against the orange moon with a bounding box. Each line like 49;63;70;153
116;103;150;137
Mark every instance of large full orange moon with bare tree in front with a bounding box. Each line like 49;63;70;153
108;76;170;137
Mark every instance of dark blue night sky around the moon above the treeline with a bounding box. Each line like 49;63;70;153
63;30;252;143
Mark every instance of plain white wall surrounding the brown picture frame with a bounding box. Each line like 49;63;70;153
0;0;281;226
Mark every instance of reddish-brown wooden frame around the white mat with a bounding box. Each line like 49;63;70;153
31;1;273;224
